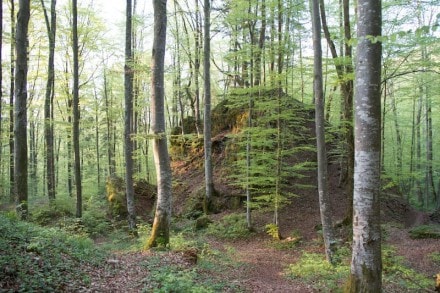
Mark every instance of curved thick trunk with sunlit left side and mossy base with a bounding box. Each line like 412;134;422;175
145;0;172;249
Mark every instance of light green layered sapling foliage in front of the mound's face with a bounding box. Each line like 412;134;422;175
228;88;315;211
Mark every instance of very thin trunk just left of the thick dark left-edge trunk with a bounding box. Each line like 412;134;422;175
9;0;15;203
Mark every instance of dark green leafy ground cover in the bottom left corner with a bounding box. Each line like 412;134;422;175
0;214;105;292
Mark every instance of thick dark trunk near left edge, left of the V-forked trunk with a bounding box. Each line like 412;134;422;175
14;0;30;219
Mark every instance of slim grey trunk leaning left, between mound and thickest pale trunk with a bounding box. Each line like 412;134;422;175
312;0;335;263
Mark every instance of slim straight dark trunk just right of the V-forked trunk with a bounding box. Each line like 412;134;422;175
72;0;82;218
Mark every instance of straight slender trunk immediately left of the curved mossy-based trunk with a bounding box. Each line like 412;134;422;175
124;0;137;235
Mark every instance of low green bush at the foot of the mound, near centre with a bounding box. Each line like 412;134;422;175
206;214;252;239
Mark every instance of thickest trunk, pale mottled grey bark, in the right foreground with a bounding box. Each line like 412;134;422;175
346;0;382;292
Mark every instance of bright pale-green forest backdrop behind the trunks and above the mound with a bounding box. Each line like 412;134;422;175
0;1;440;209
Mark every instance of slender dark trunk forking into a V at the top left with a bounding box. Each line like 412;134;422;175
41;0;56;202
